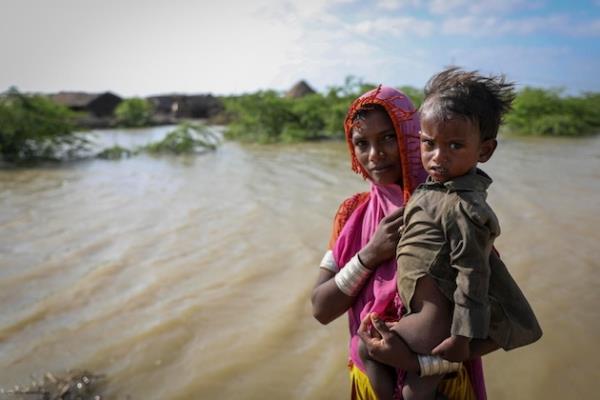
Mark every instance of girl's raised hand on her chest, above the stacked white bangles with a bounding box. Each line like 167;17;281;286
358;207;404;269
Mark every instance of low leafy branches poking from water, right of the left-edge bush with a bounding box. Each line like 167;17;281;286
143;121;219;154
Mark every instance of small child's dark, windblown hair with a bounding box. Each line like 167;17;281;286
420;67;516;140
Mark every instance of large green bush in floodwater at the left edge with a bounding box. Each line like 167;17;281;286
0;88;89;162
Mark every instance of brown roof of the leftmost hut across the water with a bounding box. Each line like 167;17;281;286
50;92;122;117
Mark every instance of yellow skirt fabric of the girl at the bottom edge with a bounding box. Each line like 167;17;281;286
348;365;475;400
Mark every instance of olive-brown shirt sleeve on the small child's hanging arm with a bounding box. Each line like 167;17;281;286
446;195;499;339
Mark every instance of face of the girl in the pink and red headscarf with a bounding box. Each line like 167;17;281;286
352;110;402;185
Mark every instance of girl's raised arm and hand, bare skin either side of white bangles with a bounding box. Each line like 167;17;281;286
311;208;404;324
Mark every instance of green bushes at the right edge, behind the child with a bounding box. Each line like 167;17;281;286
505;87;600;136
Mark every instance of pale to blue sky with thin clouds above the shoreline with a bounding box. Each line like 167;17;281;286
0;0;600;97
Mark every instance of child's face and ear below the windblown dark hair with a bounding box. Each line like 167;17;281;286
420;118;496;182
